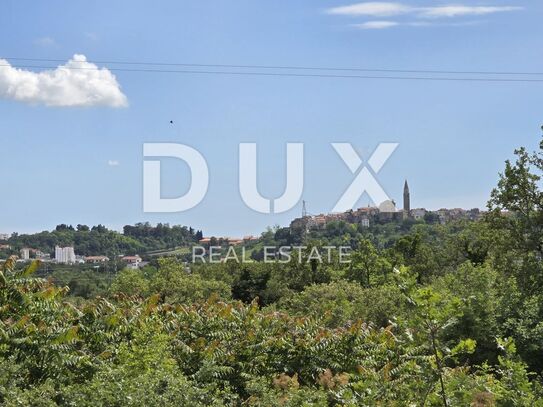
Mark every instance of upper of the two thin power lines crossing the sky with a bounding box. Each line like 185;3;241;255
0;57;543;75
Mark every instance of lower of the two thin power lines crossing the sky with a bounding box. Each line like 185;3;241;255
0;64;543;83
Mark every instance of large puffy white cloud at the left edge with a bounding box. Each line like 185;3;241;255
0;54;128;107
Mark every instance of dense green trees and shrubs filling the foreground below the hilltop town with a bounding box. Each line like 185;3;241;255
0;139;543;406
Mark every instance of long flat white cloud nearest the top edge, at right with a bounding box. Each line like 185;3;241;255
327;2;523;18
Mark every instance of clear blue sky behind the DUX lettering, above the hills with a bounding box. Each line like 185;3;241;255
0;0;543;236
